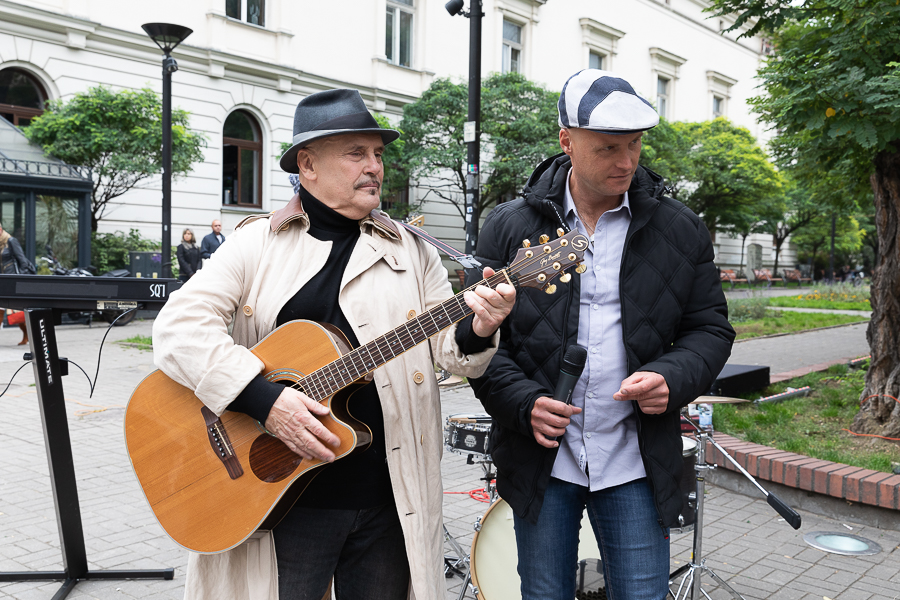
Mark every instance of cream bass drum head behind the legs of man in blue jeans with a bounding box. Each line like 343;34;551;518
470;499;600;600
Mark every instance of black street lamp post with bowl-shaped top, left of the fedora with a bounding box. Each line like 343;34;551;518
141;23;193;277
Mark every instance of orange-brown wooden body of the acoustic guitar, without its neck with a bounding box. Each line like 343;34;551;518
125;321;371;553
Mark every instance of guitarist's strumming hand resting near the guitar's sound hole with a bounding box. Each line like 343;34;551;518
266;387;341;463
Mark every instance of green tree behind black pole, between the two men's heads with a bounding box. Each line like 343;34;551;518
400;73;559;223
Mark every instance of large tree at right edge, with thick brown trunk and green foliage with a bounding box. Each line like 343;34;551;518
711;0;900;437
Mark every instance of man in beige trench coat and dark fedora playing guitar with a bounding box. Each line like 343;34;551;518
153;90;515;600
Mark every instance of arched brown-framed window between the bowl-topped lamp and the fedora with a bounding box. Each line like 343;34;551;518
222;110;262;208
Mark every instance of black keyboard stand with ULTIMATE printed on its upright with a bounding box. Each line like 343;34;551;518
0;309;175;600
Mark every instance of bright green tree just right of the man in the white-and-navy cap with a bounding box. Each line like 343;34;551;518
641;118;782;238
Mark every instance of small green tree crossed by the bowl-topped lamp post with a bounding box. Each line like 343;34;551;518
25;86;205;231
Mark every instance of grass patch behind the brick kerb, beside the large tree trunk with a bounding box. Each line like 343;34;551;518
713;365;900;473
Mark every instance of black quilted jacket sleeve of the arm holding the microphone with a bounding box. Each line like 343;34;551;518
466;209;551;438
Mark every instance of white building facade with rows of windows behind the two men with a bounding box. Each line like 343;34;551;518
0;0;794;276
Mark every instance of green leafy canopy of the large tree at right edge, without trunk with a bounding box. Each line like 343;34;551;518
711;0;900;176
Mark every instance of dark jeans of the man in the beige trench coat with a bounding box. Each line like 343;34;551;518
272;504;409;600
